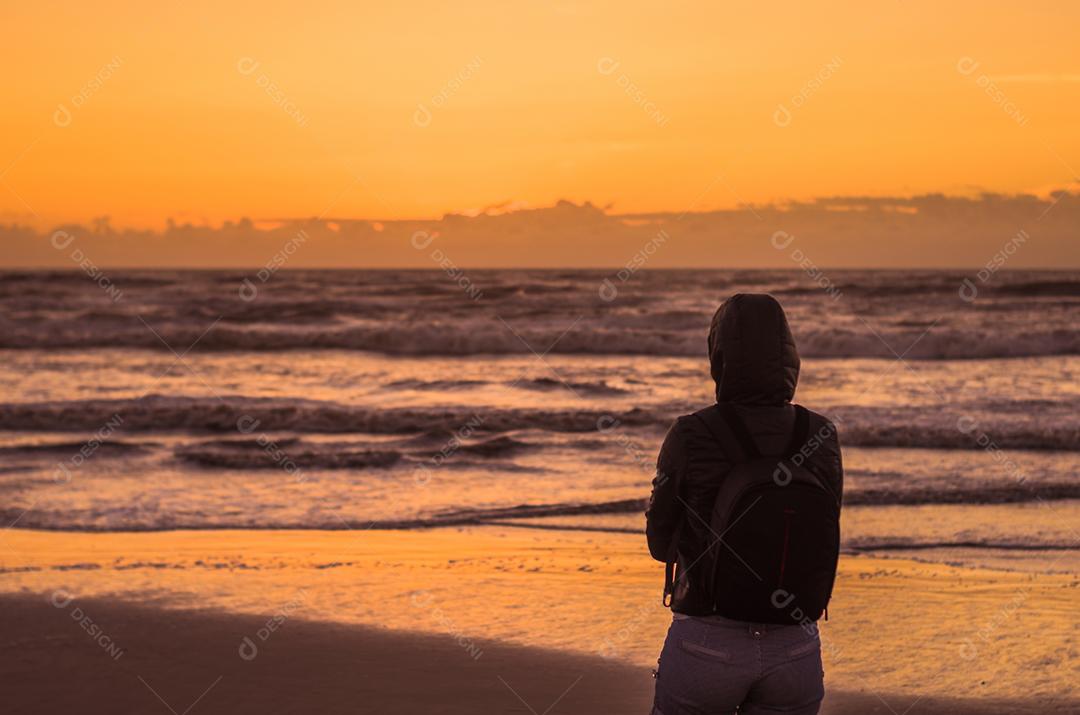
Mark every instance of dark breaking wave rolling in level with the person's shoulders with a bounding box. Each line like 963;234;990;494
0;395;1080;455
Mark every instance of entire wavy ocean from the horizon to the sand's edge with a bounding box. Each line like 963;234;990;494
0;272;1080;570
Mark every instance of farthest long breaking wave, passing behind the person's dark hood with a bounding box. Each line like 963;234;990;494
0;318;1080;358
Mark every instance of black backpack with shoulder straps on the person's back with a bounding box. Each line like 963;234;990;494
669;403;840;624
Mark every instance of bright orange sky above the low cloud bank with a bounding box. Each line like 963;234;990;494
0;0;1080;227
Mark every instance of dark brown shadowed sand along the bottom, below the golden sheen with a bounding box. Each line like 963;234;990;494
0;596;1076;715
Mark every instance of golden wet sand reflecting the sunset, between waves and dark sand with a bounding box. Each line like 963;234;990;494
0;526;1080;714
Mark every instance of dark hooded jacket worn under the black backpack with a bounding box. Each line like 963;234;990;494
646;294;843;616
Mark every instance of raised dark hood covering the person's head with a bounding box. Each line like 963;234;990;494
708;293;799;405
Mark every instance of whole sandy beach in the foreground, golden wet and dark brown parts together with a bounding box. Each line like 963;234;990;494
0;527;1080;715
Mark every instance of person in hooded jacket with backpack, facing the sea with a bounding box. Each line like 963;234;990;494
646;294;843;715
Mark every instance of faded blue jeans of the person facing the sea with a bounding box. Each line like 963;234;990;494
652;613;825;715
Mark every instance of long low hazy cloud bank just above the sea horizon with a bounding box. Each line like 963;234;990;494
0;191;1080;269
